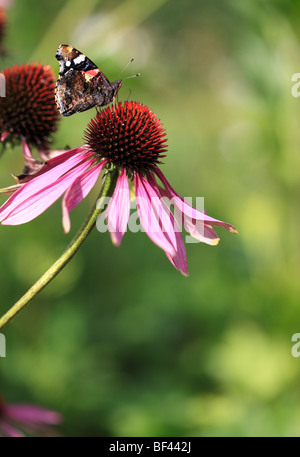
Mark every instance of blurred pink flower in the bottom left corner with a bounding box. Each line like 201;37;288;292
0;398;62;438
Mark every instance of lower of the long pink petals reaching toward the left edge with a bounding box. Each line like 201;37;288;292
0;160;91;225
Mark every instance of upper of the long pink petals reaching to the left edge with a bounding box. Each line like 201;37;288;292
0;148;87;221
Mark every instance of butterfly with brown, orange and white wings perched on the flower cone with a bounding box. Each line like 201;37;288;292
55;44;122;116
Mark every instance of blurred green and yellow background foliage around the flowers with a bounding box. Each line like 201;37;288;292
0;0;300;436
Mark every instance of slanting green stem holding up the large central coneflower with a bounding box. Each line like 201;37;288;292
0;172;117;330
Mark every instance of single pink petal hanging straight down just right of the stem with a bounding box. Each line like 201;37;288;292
107;169;130;246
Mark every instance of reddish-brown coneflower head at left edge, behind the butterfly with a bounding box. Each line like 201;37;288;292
0;63;59;171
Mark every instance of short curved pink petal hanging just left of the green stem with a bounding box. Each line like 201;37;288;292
62;161;105;233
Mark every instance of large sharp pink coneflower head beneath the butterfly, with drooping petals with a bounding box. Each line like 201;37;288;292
0;102;236;275
